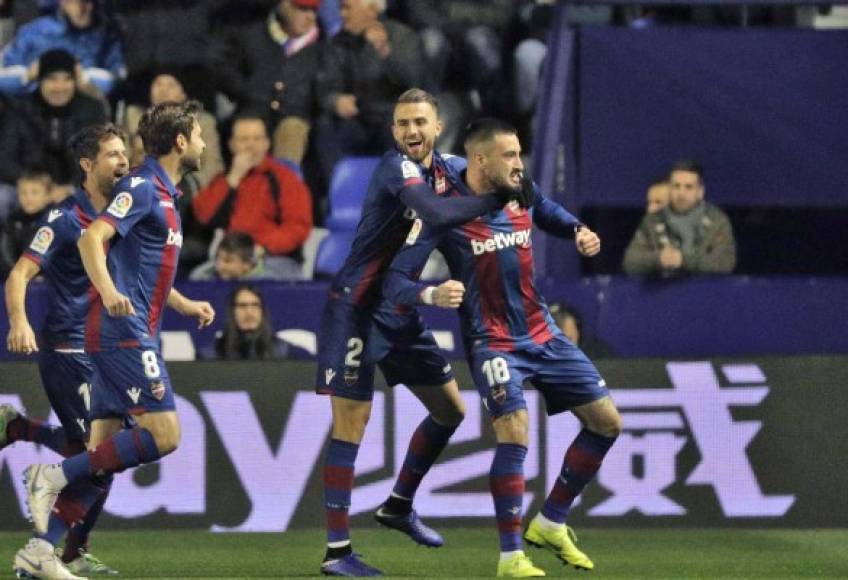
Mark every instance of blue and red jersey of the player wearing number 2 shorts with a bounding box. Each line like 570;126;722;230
332;150;468;307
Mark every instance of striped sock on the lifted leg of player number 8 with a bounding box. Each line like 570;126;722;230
62;427;161;482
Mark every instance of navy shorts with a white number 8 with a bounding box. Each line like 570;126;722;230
91;348;176;420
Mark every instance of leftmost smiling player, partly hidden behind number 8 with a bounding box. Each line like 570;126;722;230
0;123;129;577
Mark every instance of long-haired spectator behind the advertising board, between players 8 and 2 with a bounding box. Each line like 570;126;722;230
215;284;291;360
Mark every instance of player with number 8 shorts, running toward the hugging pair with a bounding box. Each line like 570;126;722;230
24;102;215;572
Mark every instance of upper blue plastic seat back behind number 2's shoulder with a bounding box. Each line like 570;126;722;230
325;157;380;231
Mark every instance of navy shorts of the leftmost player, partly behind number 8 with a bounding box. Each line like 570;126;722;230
38;350;94;441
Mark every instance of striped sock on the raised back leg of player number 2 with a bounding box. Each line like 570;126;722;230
388;415;457;513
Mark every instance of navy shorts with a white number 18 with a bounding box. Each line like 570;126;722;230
468;336;609;418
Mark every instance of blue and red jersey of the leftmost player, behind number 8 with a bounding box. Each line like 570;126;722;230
23;188;97;349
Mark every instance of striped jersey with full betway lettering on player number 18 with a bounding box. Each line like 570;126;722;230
384;183;580;352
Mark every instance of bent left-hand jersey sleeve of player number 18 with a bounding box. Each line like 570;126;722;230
383;218;445;306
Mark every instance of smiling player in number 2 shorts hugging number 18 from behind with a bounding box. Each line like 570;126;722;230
316;89;515;576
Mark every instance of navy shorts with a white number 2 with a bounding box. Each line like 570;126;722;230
315;298;453;401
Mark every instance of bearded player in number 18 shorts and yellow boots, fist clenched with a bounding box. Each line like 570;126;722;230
385;119;621;577
